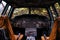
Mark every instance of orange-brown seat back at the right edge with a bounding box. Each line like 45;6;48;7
49;18;60;40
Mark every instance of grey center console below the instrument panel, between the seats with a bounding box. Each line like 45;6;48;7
25;28;37;40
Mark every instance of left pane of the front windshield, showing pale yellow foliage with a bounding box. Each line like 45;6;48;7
12;8;29;18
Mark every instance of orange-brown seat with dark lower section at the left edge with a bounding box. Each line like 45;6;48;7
0;16;15;40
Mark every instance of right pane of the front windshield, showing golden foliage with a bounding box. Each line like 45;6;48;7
31;8;49;17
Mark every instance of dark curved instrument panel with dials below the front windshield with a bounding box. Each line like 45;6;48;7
12;15;49;28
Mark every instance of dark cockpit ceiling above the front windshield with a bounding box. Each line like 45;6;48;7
4;0;57;7
